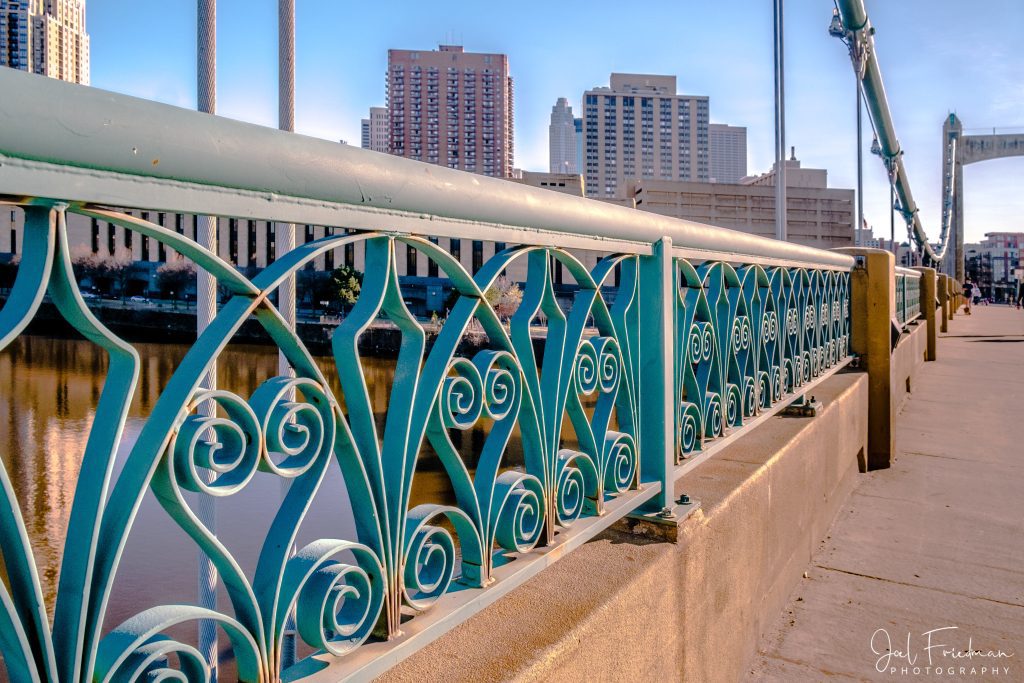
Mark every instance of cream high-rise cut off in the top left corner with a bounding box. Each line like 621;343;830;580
0;0;89;85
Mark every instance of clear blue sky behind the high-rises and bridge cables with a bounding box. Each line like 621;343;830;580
87;0;1024;241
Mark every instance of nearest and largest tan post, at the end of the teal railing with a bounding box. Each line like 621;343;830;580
836;248;896;471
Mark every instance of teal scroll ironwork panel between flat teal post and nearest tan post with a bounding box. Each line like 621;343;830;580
675;259;850;459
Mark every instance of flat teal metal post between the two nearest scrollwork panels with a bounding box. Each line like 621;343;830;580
640;238;676;514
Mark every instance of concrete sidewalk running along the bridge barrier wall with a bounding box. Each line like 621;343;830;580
748;306;1024;681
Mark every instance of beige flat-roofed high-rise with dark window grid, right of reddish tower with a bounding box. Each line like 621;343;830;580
583;74;711;198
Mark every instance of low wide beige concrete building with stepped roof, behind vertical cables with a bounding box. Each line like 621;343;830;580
630;160;854;249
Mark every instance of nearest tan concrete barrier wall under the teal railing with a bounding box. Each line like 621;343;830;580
379;373;868;683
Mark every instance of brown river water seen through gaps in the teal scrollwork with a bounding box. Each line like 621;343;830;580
0;336;522;643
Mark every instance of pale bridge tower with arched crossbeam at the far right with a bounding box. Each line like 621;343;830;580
942;114;1024;282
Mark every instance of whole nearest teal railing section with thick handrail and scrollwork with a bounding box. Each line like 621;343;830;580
0;70;854;681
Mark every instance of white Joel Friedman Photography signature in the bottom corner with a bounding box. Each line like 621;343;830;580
871;626;1014;676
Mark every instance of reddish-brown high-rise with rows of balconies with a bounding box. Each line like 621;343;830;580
387;45;514;178
